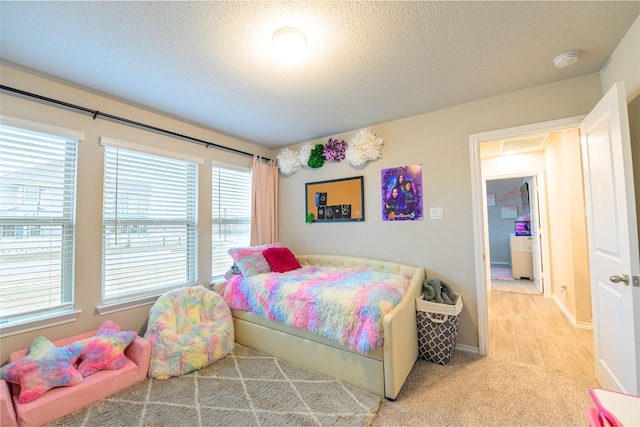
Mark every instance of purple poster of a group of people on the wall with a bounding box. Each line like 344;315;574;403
381;165;424;221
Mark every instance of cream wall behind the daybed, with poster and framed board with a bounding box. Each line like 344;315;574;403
279;74;600;348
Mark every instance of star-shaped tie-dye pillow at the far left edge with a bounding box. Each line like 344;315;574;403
0;337;83;403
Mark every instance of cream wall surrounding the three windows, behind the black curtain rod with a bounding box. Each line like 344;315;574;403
0;66;274;363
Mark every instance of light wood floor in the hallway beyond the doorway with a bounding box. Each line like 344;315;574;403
488;282;595;378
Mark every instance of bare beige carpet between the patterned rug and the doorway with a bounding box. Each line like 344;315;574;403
373;351;598;426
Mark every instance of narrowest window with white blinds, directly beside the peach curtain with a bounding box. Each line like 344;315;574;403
211;164;251;279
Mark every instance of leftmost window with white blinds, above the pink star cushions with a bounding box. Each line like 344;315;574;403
0;116;84;333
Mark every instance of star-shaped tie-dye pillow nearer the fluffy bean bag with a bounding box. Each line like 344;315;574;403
78;320;138;377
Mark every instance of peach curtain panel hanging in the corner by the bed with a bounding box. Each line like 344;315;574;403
251;156;278;246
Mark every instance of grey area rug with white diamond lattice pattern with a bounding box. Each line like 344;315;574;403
48;344;381;426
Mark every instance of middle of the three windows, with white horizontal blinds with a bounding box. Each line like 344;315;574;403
101;142;198;303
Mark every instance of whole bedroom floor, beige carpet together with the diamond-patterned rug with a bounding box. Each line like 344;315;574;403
46;346;598;426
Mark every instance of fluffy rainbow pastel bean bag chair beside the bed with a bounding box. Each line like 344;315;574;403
144;286;234;379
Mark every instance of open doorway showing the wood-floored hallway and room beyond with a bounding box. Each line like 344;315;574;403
470;118;594;376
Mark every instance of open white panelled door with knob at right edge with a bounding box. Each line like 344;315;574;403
580;83;640;395
